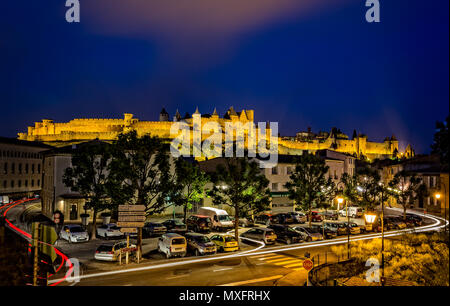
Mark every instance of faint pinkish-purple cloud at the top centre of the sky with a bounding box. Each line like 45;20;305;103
81;0;348;64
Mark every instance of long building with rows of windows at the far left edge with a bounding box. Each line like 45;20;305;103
0;137;50;198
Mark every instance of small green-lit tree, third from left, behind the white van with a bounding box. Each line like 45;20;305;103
171;157;209;223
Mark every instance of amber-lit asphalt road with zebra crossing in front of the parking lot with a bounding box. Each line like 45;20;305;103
3;198;443;286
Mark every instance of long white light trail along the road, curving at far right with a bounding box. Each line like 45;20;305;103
49;207;448;283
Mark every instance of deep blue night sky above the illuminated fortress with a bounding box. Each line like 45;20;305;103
0;0;449;153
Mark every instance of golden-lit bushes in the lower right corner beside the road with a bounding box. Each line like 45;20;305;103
331;233;449;286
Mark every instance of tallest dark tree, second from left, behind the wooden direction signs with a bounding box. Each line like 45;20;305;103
107;131;173;256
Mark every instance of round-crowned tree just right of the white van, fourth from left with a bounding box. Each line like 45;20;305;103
209;157;270;242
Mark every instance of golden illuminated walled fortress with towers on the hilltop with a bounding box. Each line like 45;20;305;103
18;107;414;159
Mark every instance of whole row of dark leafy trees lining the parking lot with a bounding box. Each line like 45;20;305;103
64;131;436;249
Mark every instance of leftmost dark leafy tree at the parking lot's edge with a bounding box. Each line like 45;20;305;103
63;141;113;239
